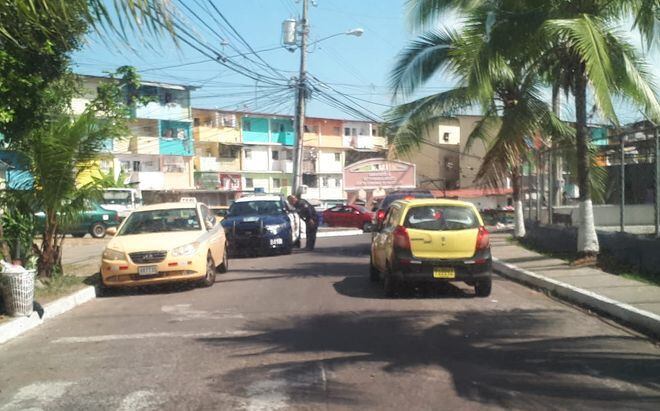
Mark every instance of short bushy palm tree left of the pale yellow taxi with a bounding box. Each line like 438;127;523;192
13;107;127;277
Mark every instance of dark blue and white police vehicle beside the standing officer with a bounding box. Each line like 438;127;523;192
222;195;300;255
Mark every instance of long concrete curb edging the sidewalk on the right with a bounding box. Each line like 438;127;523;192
493;258;660;338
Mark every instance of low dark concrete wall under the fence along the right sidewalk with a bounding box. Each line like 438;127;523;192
525;221;660;275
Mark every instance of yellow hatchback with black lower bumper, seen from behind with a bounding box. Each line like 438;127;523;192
370;199;492;297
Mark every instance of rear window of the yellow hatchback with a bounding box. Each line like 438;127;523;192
404;205;479;231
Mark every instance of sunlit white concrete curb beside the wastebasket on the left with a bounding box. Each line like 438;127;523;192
0;286;96;345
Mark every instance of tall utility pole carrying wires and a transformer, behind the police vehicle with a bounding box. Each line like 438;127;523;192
291;0;309;196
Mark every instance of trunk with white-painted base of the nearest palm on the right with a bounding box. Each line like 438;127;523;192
575;64;599;256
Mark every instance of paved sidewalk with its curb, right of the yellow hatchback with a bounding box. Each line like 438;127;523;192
491;234;660;337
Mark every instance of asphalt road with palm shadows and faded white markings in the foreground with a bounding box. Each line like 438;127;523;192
0;235;660;411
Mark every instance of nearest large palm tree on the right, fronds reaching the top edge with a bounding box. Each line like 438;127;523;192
409;0;660;256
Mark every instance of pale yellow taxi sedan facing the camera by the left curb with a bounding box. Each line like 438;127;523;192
101;202;229;287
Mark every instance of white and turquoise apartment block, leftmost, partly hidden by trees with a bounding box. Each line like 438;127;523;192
72;75;195;190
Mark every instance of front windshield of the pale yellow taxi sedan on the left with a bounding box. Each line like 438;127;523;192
118;208;201;235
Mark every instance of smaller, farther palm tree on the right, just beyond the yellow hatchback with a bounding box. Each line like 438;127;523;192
390;7;571;237
